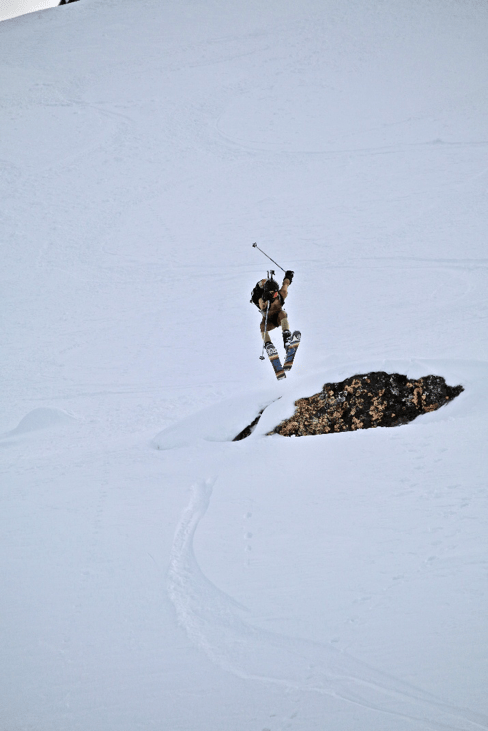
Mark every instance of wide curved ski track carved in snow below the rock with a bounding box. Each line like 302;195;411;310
168;477;488;731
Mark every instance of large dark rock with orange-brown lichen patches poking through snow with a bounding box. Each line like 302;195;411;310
270;371;464;437
